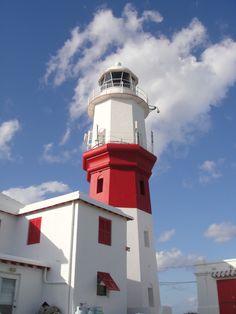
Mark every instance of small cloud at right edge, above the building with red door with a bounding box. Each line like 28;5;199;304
205;222;236;242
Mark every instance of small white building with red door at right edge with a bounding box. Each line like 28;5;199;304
195;259;236;314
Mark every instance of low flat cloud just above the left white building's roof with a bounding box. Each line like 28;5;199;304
2;181;69;204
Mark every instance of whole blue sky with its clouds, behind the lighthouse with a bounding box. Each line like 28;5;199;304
0;0;236;314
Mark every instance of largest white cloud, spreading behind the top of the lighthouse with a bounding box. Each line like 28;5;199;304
45;5;236;154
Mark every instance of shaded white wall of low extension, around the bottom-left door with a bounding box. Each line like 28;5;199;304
0;262;42;314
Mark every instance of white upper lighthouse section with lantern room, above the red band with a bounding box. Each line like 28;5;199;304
88;63;149;148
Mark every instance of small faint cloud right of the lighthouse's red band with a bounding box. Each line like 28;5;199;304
199;159;224;184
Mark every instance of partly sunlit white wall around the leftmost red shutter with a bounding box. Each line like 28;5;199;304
14;203;72;281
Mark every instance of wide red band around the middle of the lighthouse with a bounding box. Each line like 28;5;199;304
83;143;156;213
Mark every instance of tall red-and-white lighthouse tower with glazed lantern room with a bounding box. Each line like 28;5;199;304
83;63;161;314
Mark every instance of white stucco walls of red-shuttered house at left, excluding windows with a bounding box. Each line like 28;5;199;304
0;194;127;314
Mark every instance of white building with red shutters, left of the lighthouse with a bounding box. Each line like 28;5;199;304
0;192;131;314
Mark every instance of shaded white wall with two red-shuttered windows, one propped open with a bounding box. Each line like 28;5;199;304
74;203;129;314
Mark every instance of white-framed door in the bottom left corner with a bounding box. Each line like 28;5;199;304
0;273;18;314
